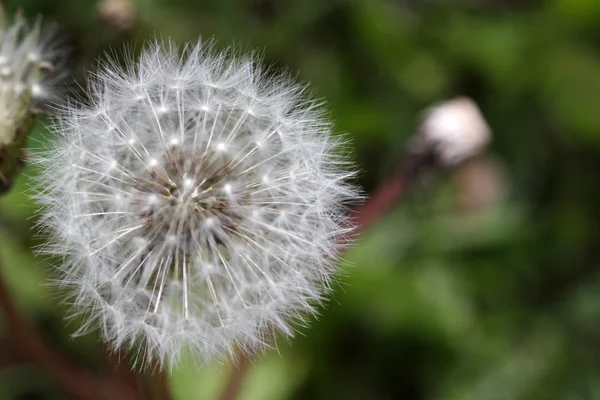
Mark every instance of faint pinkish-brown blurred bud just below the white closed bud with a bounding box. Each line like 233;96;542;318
454;157;507;212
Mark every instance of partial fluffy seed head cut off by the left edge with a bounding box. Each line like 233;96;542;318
0;9;64;147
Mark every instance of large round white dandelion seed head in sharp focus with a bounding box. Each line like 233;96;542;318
39;42;356;367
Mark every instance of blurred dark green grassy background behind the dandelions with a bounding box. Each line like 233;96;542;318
0;0;600;400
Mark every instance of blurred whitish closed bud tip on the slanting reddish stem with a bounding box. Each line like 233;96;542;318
414;97;491;166
